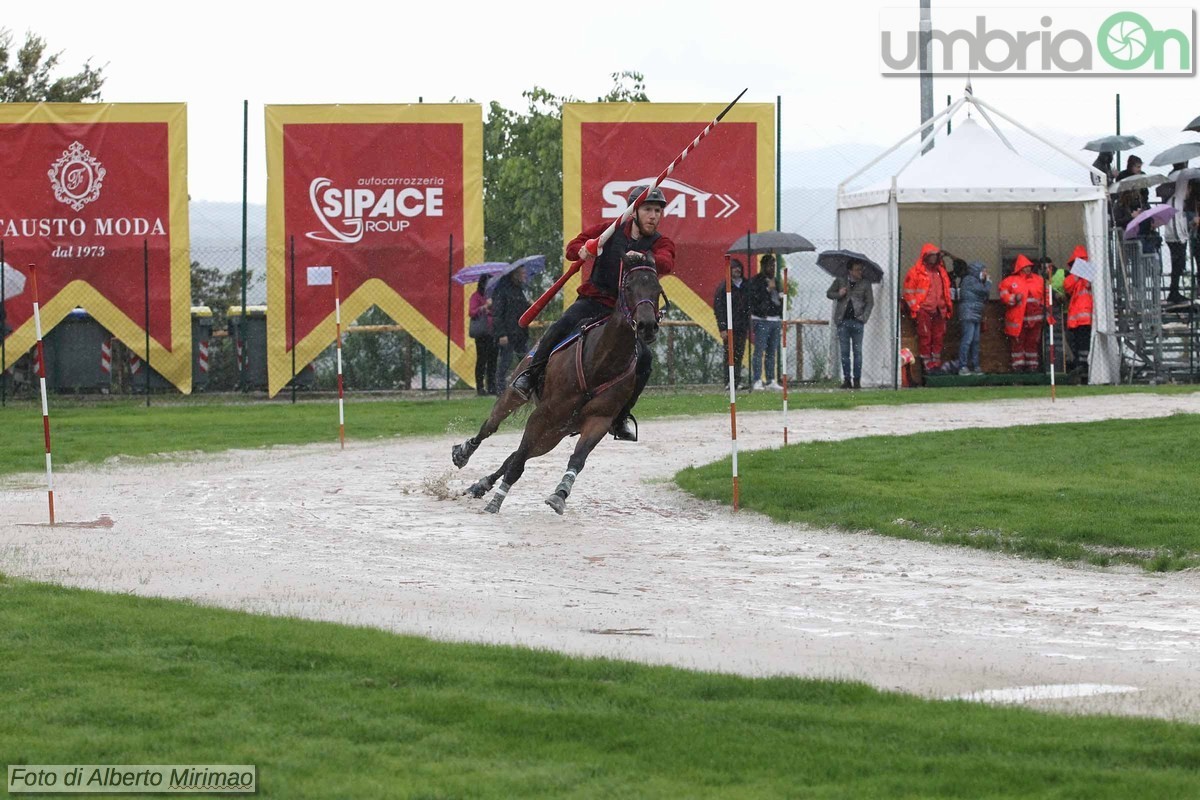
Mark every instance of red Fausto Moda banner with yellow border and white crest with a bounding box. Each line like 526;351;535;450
0;103;192;392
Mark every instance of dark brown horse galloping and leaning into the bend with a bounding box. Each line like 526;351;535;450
451;266;666;513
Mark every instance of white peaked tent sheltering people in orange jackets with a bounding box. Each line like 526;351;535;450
838;88;1120;386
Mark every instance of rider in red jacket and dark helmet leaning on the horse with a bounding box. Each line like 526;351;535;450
512;186;674;441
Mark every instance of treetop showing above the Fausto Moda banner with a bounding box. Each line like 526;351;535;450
0;28;104;103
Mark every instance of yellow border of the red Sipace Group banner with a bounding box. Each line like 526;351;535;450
264;103;484;397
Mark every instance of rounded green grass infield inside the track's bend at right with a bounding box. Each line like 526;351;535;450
676;414;1200;570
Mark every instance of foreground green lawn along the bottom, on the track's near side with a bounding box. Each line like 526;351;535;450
0;576;1200;800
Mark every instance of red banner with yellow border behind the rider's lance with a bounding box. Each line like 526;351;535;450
563;103;775;336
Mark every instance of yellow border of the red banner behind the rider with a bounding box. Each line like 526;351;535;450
563;103;775;339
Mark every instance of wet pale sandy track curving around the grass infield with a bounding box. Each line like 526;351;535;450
0;393;1200;721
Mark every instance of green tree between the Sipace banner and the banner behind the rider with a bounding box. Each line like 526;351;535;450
484;72;649;298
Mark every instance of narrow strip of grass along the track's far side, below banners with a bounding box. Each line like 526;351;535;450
0;386;1193;475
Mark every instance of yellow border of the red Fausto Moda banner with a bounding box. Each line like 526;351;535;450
0;103;192;395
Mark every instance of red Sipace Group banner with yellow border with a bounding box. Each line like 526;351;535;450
266;104;482;393
